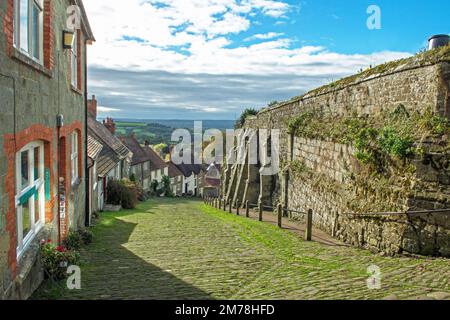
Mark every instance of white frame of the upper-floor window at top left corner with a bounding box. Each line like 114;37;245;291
13;0;44;65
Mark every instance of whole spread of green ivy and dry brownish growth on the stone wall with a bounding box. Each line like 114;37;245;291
285;105;450;212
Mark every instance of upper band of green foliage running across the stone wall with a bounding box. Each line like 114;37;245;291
288;105;450;168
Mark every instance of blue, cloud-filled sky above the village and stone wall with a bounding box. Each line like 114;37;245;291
84;0;450;120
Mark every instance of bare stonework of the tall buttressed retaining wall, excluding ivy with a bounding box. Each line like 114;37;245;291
225;53;450;256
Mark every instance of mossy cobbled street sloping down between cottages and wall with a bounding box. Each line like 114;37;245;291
33;199;450;300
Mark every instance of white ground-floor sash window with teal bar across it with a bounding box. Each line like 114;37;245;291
15;142;45;258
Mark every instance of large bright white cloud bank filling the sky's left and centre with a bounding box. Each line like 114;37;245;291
84;0;414;120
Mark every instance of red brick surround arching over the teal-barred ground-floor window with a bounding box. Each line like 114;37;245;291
3;125;55;277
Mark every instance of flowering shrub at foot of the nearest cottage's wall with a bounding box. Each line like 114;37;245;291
41;240;80;280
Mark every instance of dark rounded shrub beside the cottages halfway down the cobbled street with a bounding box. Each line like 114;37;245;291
106;179;138;209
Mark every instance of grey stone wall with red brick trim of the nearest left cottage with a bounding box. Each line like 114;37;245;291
0;0;86;299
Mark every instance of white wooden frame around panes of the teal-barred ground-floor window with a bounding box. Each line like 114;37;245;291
15;141;45;260
